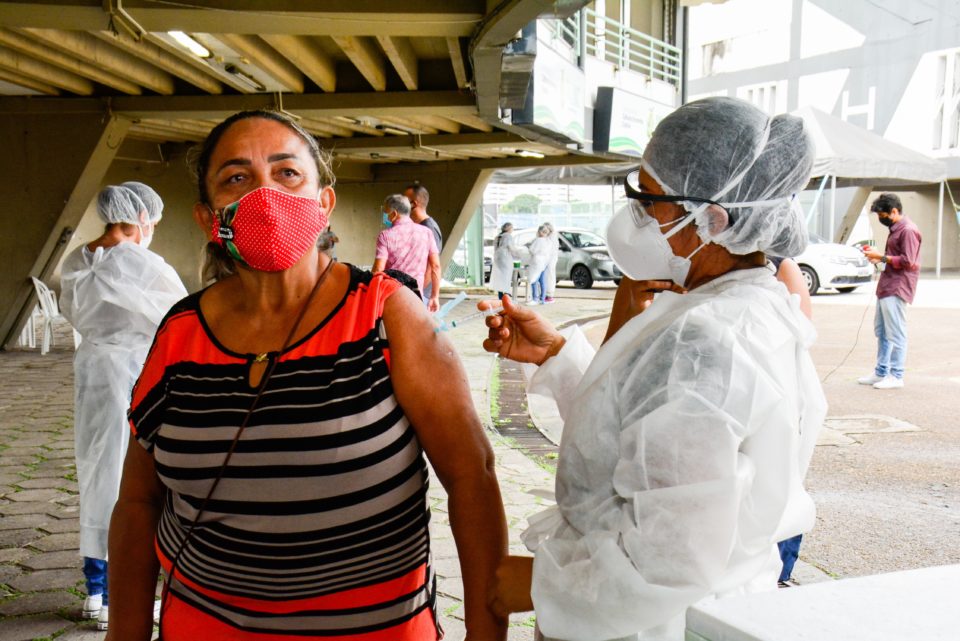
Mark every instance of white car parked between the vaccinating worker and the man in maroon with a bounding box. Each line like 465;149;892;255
794;234;875;296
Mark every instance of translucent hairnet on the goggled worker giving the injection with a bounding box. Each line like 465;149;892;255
642;97;815;256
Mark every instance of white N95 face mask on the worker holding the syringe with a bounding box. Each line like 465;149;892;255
607;200;703;285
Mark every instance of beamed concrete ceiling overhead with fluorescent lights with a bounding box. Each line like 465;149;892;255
0;0;604;174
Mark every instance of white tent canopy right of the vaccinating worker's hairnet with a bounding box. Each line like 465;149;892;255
793;107;947;189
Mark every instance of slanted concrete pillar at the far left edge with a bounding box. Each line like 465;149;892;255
0;112;130;345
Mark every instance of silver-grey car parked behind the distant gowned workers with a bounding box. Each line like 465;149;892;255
513;227;621;289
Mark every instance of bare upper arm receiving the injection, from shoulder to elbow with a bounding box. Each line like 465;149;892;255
383;289;493;487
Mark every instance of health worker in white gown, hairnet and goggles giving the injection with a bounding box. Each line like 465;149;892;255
479;98;826;641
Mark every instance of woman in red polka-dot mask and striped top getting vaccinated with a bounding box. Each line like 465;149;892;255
109;112;506;641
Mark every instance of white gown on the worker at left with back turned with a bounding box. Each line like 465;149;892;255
60;242;187;559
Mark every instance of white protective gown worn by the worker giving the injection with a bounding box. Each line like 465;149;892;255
524;268;826;641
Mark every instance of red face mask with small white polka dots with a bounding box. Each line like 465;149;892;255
213;187;328;272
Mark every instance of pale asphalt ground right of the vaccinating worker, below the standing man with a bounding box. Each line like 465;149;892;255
800;278;960;577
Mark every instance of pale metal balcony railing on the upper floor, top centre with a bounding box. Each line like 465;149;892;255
550;9;680;85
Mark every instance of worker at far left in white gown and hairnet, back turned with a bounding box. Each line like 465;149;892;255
60;182;187;629
